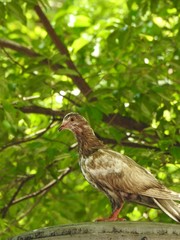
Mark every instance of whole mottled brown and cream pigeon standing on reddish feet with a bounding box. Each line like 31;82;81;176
59;112;180;222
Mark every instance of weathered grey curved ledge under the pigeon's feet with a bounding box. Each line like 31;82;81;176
11;222;180;240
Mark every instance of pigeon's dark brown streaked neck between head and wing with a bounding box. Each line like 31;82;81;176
76;127;104;157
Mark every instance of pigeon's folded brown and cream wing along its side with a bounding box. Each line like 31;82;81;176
86;148;180;200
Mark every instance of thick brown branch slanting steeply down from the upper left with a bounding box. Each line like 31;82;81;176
34;5;92;96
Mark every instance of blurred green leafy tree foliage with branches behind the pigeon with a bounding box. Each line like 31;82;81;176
0;0;180;239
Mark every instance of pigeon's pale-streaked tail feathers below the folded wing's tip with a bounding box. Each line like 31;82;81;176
153;198;180;223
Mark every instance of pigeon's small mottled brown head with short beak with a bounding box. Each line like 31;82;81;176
59;112;91;135
